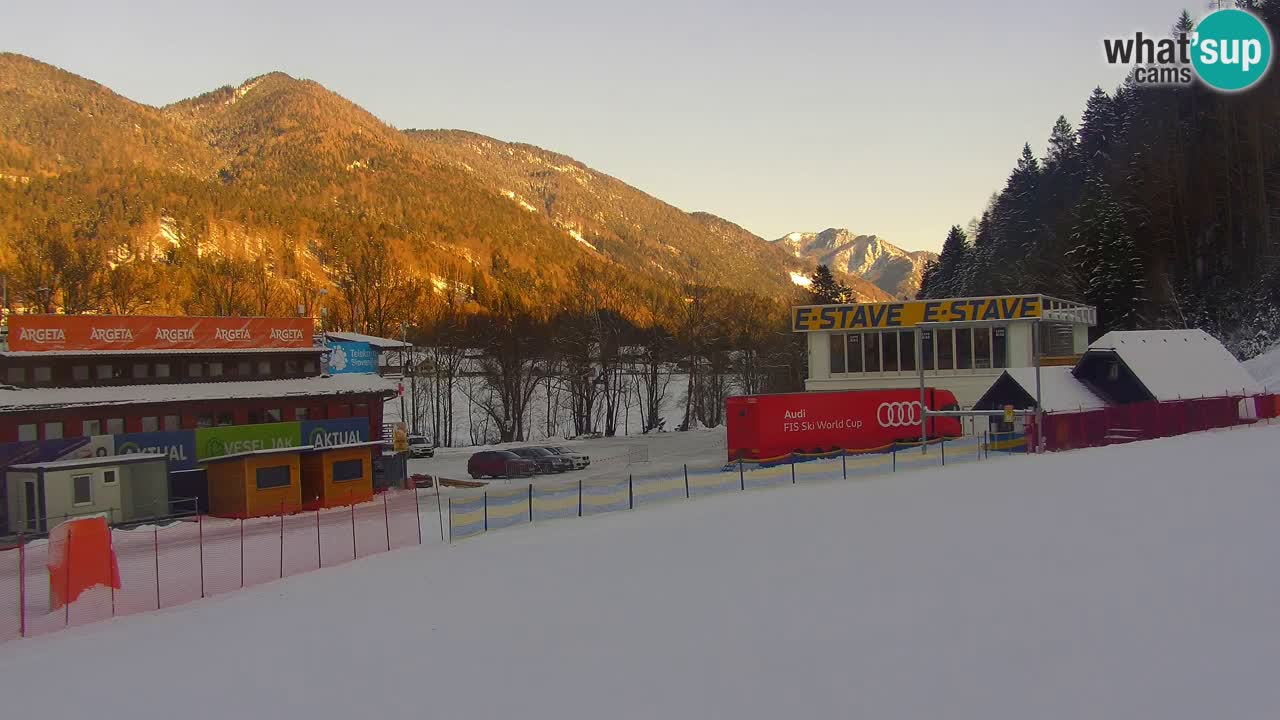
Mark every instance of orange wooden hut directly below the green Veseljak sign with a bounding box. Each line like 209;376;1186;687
206;446;311;518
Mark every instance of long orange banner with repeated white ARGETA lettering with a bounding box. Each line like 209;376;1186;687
9;315;312;352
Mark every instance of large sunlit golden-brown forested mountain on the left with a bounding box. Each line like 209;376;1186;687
0;54;812;333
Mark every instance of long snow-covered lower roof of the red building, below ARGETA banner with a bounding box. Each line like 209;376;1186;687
0;374;396;413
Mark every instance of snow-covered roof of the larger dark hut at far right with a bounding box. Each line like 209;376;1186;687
1082;331;1262;401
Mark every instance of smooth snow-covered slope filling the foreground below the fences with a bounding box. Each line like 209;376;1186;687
0;427;1280;720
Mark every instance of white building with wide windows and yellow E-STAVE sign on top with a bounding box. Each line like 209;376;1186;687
791;295;1097;407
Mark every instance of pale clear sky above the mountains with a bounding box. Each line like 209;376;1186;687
0;0;1208;250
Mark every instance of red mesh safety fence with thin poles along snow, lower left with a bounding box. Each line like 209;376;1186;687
0;489;421;642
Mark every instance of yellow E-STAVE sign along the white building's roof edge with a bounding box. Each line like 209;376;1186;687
791;295;1043;333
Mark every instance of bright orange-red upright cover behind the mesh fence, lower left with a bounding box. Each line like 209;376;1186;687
49;518;120;610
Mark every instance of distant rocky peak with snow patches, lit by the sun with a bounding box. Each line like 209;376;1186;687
774;228;938;300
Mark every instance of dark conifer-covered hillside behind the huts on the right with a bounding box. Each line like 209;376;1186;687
922;0;1280;356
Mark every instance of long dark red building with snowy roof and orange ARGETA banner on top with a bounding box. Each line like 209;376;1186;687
0;315;396;443
